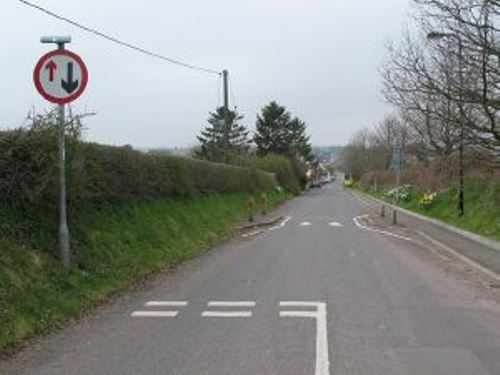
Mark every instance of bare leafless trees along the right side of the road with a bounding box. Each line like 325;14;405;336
343;0;500;182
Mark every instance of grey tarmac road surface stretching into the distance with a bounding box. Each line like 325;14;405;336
0;186;500;375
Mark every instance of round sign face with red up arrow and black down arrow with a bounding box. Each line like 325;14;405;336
33;49;88;104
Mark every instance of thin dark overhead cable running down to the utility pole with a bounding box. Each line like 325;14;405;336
17;0;222;75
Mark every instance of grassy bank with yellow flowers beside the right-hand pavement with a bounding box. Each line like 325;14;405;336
359;177;500;241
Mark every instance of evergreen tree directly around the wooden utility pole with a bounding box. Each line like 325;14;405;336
195;107;250;164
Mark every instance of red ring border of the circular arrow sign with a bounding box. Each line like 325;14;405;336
33;49;89;104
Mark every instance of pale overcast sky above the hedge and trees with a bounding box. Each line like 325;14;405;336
0;0;410;148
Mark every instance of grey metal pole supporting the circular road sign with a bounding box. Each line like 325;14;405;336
57;43;71;268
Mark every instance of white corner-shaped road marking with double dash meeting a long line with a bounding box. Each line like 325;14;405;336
280;301;330;375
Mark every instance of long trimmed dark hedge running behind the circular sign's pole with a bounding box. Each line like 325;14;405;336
0;129;276;206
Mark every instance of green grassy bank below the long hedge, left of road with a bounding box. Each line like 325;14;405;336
0;191;289;352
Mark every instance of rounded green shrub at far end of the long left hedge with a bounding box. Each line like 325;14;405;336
251;154;300;195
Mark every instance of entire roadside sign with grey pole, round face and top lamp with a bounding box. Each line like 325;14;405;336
33;36;88;268
